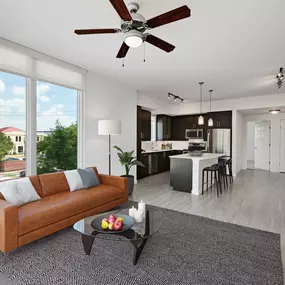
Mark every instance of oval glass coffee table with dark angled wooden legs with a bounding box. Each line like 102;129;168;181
73;203;162;265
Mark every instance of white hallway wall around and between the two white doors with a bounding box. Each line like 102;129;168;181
243;113;285;172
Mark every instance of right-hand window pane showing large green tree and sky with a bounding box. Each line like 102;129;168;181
37;81;78;174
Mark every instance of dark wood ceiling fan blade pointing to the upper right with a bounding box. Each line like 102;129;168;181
146;5;191;28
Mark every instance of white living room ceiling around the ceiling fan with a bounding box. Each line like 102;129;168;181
0;0;285;102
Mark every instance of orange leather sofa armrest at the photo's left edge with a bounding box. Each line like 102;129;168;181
0;199;18;253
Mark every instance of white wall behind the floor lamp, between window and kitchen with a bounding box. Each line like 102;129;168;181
84;72;137;175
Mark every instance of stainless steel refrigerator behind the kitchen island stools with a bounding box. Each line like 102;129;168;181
207;129;231;156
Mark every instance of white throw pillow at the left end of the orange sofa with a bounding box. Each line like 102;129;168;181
0;178;41;206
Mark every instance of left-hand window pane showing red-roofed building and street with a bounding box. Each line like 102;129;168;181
0;72;26;181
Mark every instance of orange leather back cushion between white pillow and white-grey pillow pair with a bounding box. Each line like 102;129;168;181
39;172;69;197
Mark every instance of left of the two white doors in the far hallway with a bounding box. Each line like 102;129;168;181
255;122;270;170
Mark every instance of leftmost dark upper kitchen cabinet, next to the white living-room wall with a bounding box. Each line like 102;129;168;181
137;106;151;141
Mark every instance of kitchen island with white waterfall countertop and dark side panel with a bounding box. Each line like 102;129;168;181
169;153;223;195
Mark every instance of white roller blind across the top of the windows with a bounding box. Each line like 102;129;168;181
0;39;86;90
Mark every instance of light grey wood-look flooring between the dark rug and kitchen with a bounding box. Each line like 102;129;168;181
129;170;285;278
